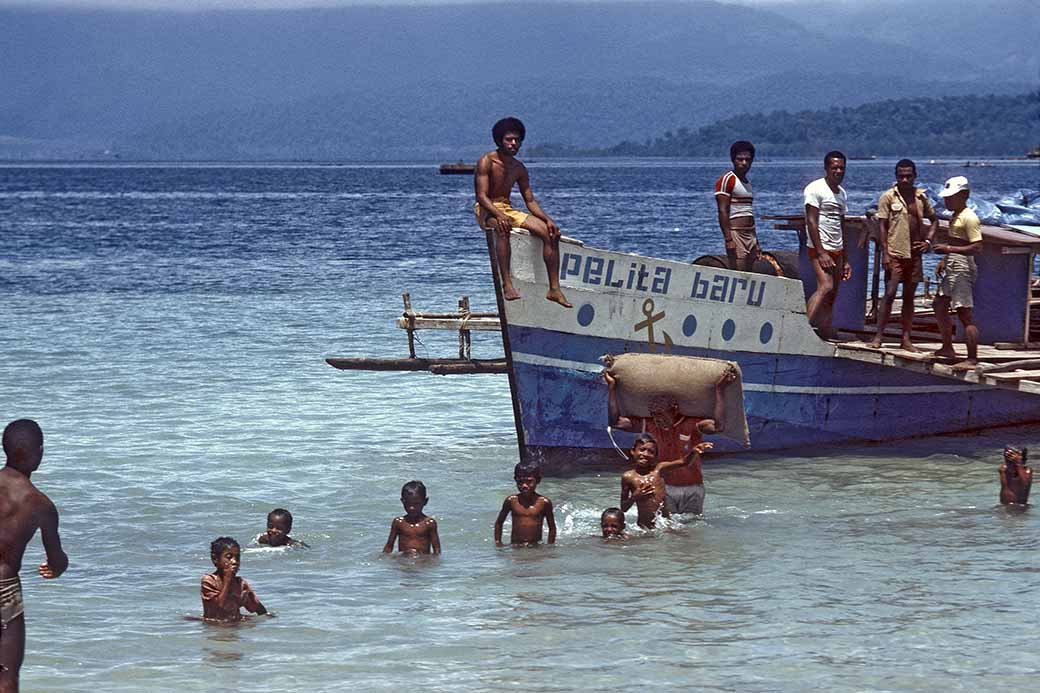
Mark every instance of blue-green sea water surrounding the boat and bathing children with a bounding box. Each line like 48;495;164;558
0;160;1040;692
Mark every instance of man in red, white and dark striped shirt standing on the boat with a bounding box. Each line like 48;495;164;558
716;139;760;272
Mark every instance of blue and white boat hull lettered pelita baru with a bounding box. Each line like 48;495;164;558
492;233;1040;468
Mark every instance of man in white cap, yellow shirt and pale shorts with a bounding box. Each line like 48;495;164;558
932;176;982;370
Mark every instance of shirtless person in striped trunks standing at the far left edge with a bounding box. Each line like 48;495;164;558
0;418;69;693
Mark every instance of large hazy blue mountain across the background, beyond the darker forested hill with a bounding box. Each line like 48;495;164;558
0;0;1036;159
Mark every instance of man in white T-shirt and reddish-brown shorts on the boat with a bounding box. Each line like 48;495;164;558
804;151;852;339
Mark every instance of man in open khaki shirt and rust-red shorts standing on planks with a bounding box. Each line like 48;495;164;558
870;159;939;352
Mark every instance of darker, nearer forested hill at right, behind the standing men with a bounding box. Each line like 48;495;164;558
527;93;1040;156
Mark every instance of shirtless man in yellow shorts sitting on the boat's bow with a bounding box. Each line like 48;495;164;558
473;118;571;308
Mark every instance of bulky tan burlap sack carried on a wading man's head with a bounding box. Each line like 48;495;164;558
603;354;751;446
